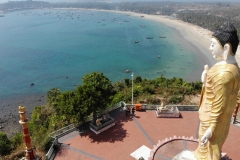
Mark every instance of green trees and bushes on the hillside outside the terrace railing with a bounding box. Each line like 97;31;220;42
0;72;202;159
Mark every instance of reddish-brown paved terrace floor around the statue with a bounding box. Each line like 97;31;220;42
55;110;240;160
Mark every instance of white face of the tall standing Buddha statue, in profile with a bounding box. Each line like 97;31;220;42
209;38;224;61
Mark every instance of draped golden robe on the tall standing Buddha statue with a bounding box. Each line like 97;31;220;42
194;64;240;160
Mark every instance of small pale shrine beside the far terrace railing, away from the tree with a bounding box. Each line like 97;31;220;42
156;99;180;118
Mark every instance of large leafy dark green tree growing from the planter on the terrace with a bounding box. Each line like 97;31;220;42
77;72;115;122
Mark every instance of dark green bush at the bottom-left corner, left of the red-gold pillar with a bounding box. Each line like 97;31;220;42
0;132;12;156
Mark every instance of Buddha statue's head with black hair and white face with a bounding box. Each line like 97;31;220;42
209;22;239;61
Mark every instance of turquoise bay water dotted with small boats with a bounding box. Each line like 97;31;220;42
0;10;206;97
